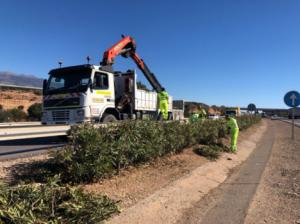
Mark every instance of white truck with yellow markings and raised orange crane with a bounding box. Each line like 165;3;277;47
42;36;178;125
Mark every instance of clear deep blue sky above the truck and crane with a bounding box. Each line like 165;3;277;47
0;0;300;108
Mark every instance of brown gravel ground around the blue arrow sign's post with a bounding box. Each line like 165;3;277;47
245;121;300;224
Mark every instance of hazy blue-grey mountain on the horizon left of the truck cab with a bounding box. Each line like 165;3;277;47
0;71;43;88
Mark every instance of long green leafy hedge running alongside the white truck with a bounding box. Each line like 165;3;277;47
52;116;260;183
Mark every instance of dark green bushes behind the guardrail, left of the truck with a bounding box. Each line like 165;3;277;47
0;103;42;122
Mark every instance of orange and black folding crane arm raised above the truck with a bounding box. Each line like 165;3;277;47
101;36;163;92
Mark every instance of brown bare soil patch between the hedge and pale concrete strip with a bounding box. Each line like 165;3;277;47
84;148;208;208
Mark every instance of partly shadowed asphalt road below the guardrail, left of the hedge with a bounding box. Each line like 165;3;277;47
0;137;66;160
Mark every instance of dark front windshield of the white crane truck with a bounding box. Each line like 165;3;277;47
46;70;91;93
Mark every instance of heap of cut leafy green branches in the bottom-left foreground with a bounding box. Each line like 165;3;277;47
0;176;119;224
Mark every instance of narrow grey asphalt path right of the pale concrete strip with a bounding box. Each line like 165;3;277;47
178;122;275;224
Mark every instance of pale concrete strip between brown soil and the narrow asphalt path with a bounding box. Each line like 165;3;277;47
105;121;267;224
